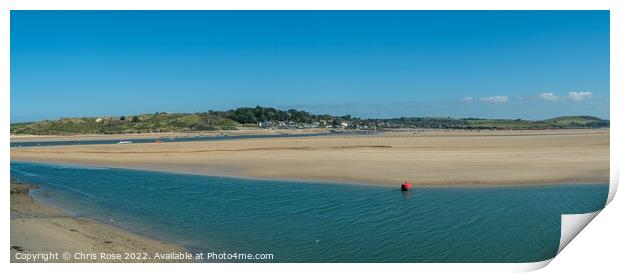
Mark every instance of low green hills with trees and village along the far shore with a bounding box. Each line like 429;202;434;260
11;106;609;135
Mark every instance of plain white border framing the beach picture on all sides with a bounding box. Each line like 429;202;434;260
0;0;620;272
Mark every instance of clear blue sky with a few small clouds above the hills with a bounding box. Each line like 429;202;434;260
11;11;610;122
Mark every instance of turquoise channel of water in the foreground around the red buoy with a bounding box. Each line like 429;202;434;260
11;162;608;262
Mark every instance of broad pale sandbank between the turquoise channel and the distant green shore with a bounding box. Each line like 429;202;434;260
11;129;610;186
